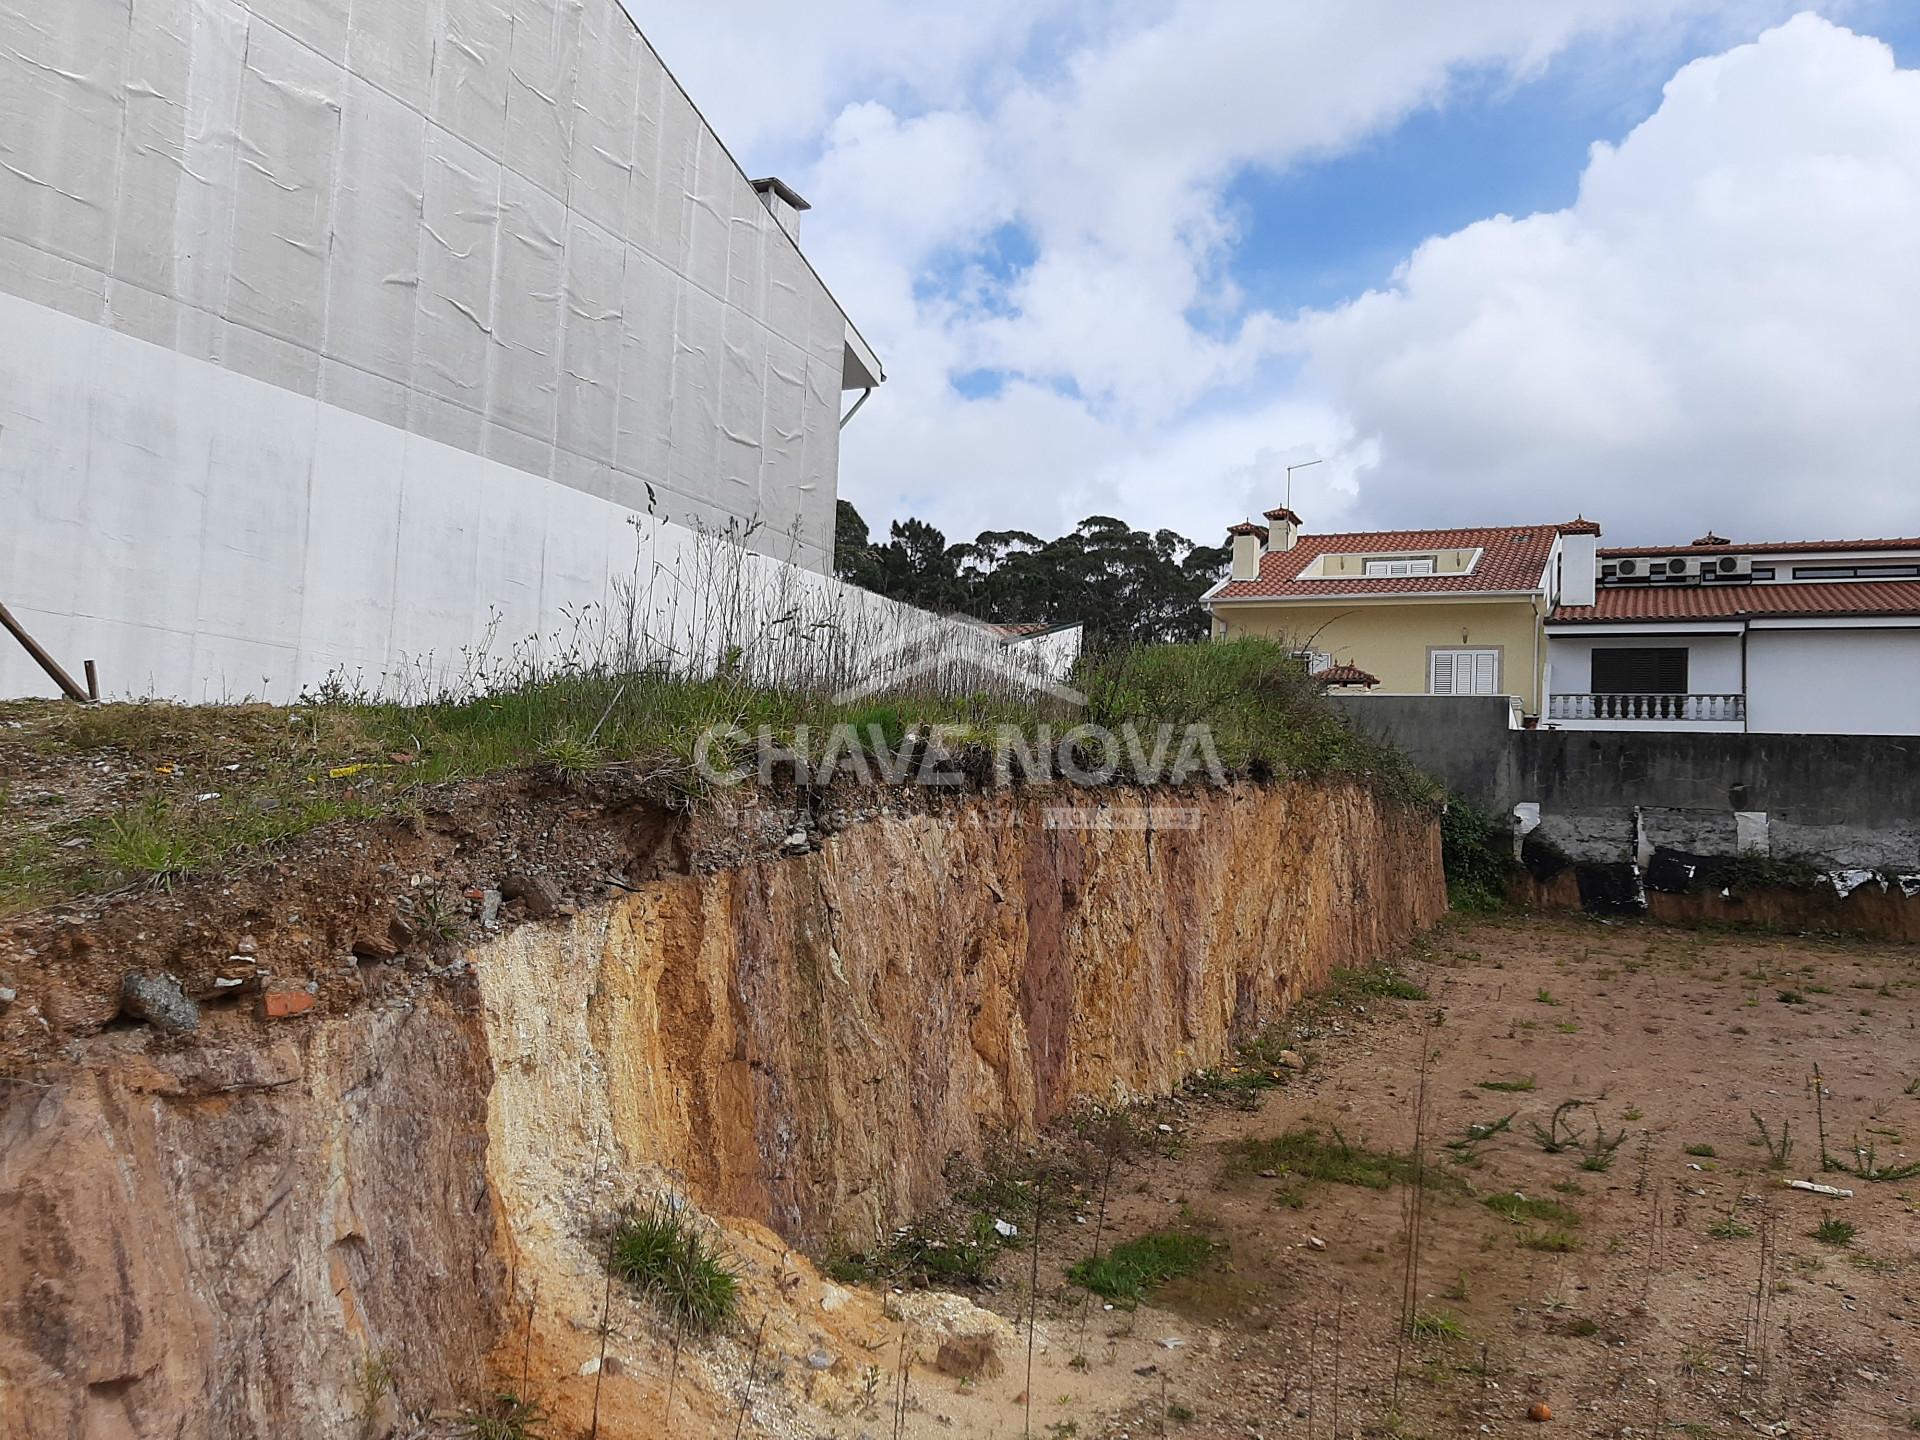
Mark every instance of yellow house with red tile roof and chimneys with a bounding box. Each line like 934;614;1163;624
1204;509;1599;716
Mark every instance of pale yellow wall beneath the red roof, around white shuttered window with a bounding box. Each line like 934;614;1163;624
1213;599;1548;714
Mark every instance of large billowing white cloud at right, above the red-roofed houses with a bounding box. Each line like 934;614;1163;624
1298;15;1920;540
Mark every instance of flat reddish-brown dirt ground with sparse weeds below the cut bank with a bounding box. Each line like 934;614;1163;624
871;916;1920;1440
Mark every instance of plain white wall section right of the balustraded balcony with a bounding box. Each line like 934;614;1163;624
1747;626;1920;735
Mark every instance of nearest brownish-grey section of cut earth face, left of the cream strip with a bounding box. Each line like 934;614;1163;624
0;985;505;1440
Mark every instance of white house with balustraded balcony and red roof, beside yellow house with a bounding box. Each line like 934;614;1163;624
1542;534;1920;735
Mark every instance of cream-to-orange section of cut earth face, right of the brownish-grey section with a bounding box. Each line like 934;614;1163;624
487;787;1444;1242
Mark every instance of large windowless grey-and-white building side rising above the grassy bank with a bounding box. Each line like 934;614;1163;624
0;0;883;701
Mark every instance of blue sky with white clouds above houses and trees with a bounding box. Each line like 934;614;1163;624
628;0;1920;543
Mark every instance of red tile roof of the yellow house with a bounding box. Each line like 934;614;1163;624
1212;524;1555;601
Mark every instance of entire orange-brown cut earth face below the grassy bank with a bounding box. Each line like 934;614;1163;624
0;785;1446;1440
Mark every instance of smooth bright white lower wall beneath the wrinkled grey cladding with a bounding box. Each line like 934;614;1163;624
0;294;1006;701
